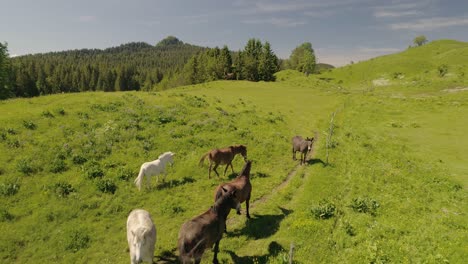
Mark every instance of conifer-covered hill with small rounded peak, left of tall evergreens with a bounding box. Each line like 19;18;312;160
8;36;206;97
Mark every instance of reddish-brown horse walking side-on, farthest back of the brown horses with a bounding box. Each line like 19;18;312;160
200;145;247;179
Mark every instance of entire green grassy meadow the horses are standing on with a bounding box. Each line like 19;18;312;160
0;41;468;263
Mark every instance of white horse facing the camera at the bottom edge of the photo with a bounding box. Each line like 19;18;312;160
127;209;156;264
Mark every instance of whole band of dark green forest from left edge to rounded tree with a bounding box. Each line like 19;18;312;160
0;36;315;99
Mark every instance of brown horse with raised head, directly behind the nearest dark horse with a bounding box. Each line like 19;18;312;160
215;160;252;218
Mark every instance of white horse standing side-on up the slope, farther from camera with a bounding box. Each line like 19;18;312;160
135;151;175;190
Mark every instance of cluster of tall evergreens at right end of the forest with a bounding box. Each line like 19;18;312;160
184;39;279;84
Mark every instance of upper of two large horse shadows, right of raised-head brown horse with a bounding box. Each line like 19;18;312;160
228;207;293;240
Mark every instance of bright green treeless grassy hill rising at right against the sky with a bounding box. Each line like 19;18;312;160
322;40;468;88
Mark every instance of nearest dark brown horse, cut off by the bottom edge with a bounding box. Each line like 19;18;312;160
178;190;240;264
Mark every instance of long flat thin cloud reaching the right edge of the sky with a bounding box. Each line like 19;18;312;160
389;17;468;31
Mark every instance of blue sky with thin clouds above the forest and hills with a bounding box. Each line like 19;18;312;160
0;0;468;66
